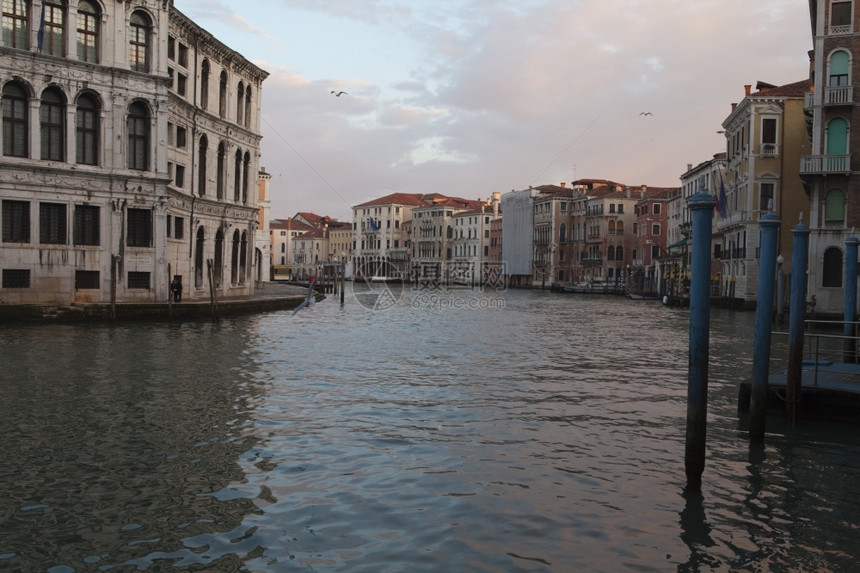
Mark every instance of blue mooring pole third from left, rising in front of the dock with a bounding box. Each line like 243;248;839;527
785;219;809;424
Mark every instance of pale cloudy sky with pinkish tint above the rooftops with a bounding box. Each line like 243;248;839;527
175;0;812;220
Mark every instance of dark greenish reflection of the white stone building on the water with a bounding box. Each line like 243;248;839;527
0;323;266;571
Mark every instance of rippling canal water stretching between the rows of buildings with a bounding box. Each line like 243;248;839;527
0;285;860;573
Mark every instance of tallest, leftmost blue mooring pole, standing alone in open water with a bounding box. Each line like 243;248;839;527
684;193;716;490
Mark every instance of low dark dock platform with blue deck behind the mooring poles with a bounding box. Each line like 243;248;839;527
738;360;860;423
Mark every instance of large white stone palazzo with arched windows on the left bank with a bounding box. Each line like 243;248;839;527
0;0;267;305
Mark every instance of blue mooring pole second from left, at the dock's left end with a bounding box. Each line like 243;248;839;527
749;213;780;442
